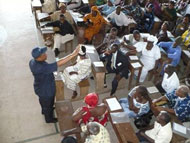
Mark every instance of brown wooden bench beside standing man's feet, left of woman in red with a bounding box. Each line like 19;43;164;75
55;100;81;143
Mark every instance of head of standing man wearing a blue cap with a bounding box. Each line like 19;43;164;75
32;47;47;61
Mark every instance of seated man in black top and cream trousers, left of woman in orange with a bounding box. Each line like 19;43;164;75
45;14;74;57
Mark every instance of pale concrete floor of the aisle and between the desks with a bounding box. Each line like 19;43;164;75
0;0;143;143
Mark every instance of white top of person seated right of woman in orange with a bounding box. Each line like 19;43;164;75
108;10;135;26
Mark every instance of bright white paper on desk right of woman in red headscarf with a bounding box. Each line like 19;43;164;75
106;98;122;111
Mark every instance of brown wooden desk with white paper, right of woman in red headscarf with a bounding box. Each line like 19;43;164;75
105;96;139;143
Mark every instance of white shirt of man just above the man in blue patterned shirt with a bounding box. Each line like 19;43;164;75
162;72;179;93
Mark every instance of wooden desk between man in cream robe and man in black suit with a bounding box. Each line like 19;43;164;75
85;45;106;92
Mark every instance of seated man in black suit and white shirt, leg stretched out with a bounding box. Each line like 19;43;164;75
102;43;129;96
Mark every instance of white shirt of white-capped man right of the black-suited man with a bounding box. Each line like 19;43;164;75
134;42;161;69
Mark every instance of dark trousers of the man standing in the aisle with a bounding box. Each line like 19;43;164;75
39;96;55;122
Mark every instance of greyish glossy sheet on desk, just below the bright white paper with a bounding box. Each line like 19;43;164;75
110;112;130;124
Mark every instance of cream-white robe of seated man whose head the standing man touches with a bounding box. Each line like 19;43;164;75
63;56;91;91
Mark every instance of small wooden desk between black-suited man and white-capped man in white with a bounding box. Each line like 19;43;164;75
128;60;143;90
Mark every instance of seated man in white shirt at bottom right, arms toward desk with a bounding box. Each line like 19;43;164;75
137;111;173;143
